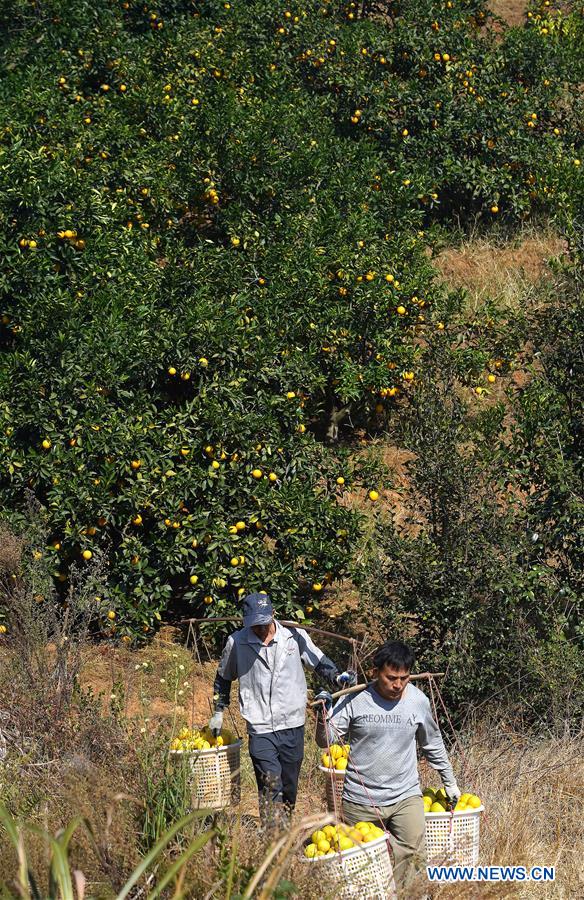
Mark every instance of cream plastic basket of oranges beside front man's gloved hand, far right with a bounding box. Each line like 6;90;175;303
422;788;484;866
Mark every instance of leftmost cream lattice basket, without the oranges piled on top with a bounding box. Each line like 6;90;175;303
170;741;242;809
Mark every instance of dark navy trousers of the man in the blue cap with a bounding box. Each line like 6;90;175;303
249;725;304;823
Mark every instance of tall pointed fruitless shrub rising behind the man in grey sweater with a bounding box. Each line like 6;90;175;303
354;339;536;703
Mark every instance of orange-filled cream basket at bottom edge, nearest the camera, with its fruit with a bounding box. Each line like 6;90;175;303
304;822;395;900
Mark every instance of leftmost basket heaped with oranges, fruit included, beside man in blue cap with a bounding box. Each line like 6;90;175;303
170;728;242;809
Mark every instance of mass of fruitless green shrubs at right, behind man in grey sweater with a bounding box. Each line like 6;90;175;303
357;258;584;723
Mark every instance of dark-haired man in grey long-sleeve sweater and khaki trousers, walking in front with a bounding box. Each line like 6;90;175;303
317;641;460;897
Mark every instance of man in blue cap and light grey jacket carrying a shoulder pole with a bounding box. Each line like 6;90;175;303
209;594;357;823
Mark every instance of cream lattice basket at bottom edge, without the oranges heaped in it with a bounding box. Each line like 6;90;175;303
302;836;396;900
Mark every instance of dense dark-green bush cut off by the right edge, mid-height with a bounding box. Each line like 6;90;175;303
507;236;584;645
